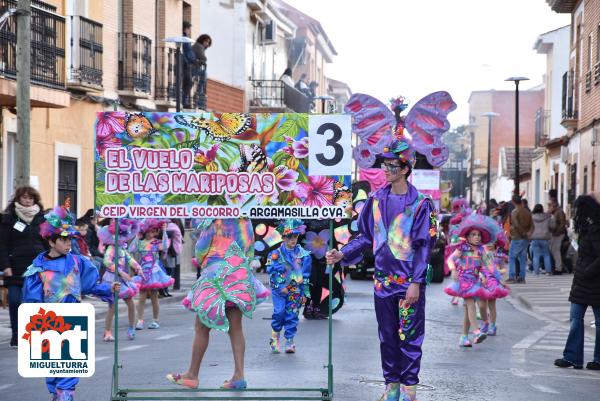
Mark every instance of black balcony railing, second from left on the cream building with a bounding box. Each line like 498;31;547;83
69;16;102;88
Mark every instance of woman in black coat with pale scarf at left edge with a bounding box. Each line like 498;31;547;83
0;186;48;347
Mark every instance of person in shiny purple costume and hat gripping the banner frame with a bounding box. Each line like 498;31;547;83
326;140;436;401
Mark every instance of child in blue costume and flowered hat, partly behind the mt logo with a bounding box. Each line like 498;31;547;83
23;206;120;401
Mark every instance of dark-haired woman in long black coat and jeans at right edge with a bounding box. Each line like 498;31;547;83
554;195;600;370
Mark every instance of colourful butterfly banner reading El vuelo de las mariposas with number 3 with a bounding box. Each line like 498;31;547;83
95;112;352;219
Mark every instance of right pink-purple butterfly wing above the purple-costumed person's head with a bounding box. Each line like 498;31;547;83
404;91;456;167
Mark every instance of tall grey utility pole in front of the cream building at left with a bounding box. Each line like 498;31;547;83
15;0;31;187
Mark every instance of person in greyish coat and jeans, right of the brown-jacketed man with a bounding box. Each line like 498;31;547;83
529;204;555;275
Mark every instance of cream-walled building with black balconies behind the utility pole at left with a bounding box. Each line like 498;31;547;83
0;0;202;215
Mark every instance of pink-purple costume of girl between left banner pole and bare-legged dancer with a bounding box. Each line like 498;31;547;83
131;219;175;291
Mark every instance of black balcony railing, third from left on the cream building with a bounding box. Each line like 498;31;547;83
119;33;152;94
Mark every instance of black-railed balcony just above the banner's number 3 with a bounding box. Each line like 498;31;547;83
250;79;311;113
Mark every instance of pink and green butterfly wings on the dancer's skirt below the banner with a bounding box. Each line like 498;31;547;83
186;242;256;331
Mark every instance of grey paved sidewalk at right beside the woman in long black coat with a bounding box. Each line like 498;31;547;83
510;272;595;335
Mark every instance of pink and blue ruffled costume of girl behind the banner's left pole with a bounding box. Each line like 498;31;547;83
98;219;142;299
